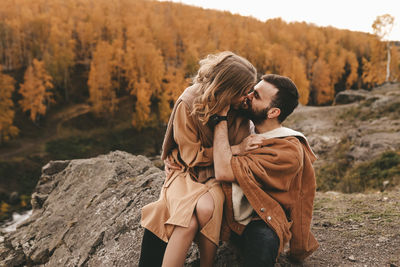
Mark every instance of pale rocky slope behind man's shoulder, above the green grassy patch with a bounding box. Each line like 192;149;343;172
286;83;400;168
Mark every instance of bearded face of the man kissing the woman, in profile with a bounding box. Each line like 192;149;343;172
241;80;278;123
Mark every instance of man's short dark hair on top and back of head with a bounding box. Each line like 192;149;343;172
261;74;299;122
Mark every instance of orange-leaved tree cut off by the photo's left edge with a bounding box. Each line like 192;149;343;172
0;66;19;144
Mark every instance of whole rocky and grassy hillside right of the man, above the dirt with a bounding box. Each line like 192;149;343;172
286;83;400;192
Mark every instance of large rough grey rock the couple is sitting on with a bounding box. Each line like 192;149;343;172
0;151;244;267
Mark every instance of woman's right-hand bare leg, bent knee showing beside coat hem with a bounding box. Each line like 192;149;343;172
196;192;217;267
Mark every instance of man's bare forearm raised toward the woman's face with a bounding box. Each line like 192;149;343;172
213;106;236;182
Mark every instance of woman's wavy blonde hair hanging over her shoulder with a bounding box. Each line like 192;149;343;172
192;51;257;124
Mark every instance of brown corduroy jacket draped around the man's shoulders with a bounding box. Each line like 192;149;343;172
221;136;318;261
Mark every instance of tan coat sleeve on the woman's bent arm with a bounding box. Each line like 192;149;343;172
173;102;213;167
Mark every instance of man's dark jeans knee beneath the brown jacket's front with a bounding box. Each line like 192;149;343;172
232;220;279;267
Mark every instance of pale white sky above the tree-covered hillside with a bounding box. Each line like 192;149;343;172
159;0;400;41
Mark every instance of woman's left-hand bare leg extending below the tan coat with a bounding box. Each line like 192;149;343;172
162;215;199;267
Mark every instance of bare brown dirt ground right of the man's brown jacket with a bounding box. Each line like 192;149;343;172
276;188;400;267
